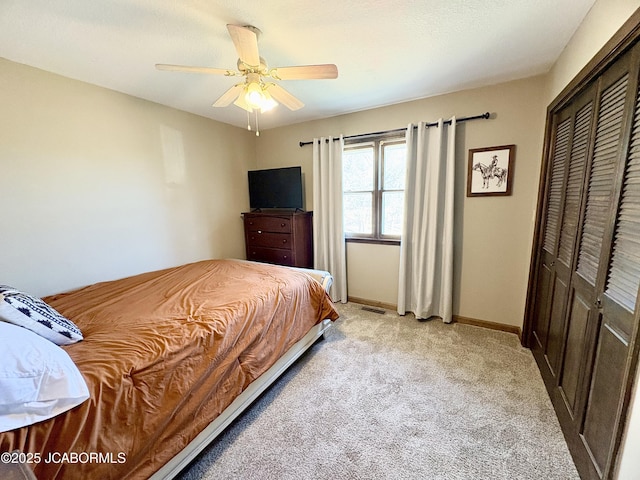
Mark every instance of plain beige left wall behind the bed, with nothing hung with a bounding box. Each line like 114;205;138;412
0;59;255;296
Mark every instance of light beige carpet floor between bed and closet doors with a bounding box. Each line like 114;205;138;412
181;303;579;480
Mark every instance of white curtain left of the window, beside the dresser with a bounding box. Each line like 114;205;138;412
313;136;347;303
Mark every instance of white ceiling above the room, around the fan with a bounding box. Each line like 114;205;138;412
0;0;594;130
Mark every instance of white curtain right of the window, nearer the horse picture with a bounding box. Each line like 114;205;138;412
398;118;456;323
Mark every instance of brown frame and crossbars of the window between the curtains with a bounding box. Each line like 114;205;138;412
343;133;406;245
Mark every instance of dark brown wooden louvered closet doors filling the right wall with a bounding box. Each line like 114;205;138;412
523;17;640;480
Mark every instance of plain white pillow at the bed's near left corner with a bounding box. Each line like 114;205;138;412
0;322;89;432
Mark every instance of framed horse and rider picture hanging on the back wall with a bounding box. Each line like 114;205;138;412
467;145;516;197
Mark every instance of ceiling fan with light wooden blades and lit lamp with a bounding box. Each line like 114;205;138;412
156;25;338;122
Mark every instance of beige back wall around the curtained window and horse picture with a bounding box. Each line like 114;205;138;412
257;77;545;327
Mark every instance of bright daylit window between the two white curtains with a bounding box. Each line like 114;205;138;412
342;137;406;241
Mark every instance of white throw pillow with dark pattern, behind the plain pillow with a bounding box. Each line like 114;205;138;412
0;285;83;345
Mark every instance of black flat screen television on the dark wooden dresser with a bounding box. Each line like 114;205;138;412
249;167;302;210
